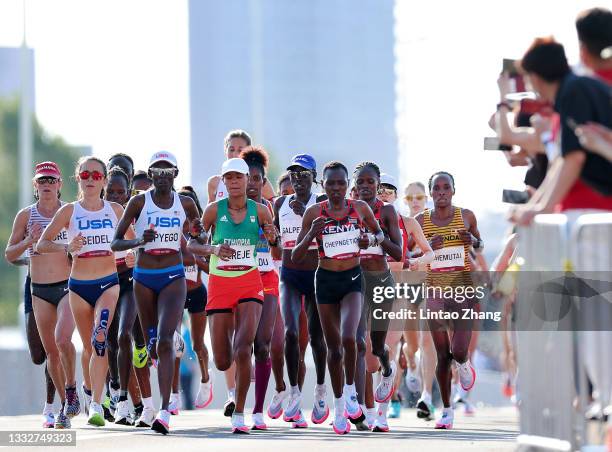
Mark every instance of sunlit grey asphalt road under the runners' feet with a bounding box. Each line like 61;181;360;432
0;407;518;452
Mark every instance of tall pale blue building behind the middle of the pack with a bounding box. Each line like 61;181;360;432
189;0;398;194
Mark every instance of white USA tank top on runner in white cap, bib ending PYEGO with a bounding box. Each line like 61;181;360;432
134;190;187;254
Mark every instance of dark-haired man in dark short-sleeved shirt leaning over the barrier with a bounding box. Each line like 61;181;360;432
513;38;612;225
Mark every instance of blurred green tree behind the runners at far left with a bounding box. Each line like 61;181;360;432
0;99;80;326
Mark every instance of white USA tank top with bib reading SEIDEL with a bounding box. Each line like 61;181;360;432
68;201;118;258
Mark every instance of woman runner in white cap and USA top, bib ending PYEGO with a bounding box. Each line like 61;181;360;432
112;151;198;435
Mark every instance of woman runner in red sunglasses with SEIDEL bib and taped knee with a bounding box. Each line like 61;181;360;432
37;157;128;426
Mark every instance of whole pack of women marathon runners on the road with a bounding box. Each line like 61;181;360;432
6;130;482;434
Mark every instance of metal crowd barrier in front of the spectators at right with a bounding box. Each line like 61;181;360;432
516;213;612;451
